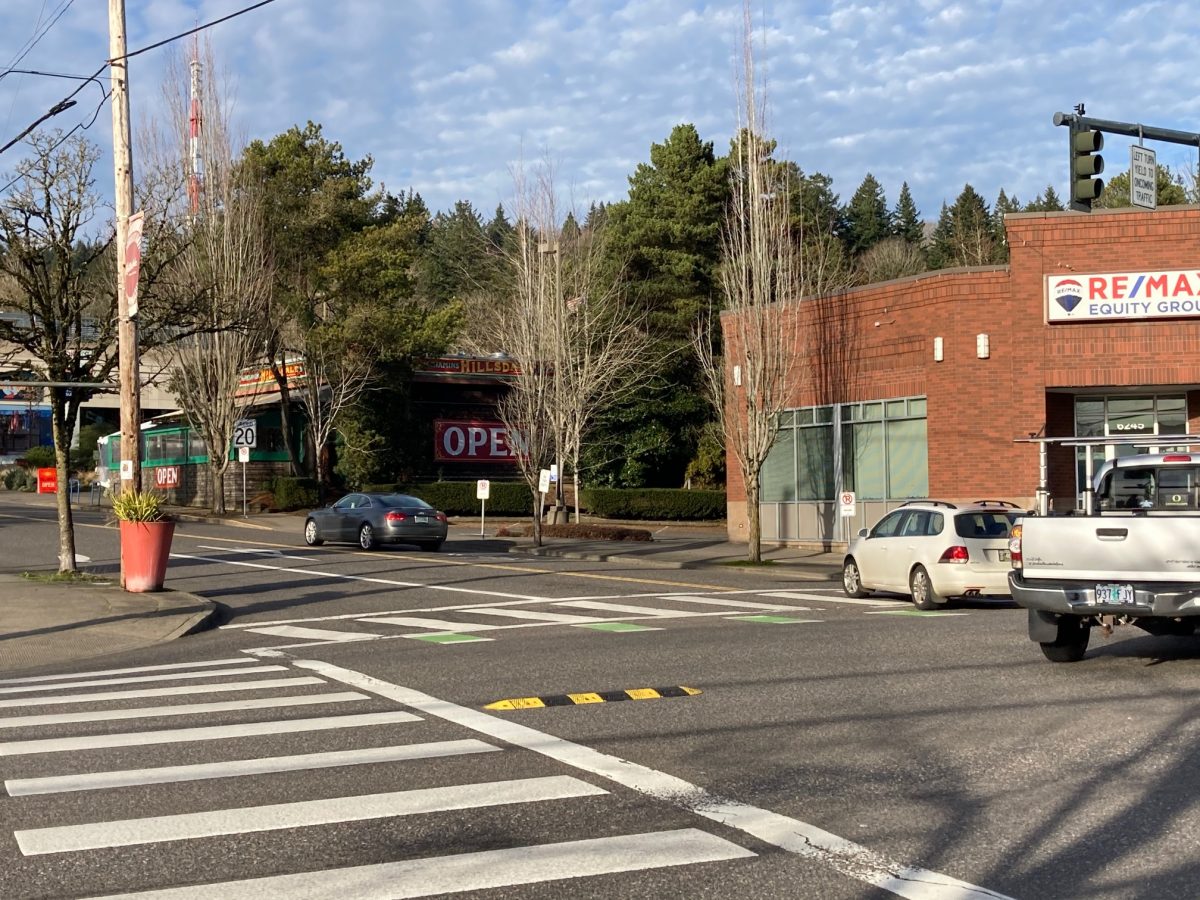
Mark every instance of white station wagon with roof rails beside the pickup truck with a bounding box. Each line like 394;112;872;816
841;500;1024;610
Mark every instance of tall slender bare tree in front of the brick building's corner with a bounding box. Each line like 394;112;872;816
695;6;803;563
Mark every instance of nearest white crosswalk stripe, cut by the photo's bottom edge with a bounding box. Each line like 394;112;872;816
91;828;755;900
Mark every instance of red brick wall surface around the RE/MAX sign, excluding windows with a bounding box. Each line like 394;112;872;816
726;206;1200;511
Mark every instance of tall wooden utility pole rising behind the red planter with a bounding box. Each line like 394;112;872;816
108;0;142;491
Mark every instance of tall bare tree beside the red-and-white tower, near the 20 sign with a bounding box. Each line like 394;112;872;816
160;47;271;514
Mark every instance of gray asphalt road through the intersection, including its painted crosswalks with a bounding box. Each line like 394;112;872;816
0;504;1200;900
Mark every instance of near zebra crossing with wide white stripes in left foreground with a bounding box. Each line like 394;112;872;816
0;656;756;900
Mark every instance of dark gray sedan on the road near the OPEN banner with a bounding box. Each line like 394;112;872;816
304;493;446;550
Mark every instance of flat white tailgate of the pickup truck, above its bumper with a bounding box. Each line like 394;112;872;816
1021;515;1200;582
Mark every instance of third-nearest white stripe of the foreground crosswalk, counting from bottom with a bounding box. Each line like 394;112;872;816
5;738;500;797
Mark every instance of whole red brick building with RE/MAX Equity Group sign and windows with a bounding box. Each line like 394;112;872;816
726;206;1200;546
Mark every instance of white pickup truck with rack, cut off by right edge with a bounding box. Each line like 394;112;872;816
1008;452;1200;662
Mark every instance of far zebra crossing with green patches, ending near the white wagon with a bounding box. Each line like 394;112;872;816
223;590;911;653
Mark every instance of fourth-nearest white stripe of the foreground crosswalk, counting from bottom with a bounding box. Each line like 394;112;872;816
0;713;421;756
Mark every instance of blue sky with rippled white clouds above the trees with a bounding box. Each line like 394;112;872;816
0;0;1200;220
